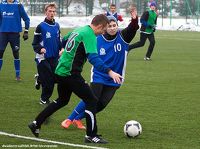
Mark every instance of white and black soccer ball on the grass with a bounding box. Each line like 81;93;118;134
124;120;142;138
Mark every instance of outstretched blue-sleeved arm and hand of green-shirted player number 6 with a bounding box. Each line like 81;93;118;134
87;53;122;84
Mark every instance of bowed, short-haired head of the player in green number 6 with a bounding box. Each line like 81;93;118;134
90;14;109;35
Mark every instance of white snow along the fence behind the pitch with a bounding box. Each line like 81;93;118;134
30;16;200;32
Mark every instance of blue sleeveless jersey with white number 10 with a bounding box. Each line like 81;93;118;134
91;31;129;86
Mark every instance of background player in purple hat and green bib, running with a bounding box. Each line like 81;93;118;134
129;2;157;61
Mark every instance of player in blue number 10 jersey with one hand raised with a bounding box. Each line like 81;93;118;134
61;7;139;129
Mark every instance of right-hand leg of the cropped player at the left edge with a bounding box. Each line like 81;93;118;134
8;33;20;81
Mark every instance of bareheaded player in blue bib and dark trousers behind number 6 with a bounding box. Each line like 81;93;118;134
32;3;62;104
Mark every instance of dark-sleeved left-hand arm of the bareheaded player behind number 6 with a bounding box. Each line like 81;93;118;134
32;25;44;54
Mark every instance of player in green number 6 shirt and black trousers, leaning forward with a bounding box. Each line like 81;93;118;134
29;14;122;144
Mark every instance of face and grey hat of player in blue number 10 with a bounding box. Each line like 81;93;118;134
106;16;118;36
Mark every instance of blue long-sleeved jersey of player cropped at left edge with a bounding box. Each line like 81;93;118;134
0;2;30;33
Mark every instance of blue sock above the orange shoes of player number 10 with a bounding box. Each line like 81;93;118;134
68;101;85;120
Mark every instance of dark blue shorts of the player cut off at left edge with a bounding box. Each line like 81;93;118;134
0;32;20;51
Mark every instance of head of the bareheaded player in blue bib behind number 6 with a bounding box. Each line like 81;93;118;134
44;3;56;20
